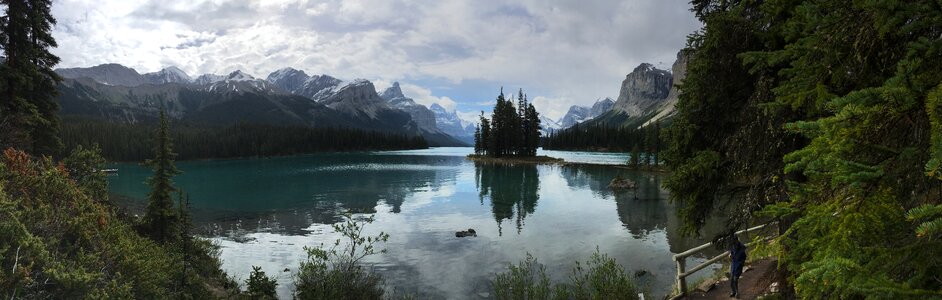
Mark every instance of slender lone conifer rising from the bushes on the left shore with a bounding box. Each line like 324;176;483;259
144;105;180;243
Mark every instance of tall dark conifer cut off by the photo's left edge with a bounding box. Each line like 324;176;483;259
0;0;62;155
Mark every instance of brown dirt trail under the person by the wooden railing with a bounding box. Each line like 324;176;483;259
685;259;778;299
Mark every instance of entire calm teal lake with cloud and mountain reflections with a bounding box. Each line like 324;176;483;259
109;148;724;299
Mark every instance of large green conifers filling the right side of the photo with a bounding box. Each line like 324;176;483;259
663;0;942;299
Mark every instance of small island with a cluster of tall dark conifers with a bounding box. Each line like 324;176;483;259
468;88;563;164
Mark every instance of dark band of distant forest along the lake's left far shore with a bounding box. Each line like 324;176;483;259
61;117;428;161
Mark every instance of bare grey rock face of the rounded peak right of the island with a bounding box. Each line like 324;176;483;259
614;63;674;117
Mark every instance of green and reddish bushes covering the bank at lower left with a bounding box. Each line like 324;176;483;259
0;150;232;299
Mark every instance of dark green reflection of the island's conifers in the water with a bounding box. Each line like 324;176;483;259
474;163;540;235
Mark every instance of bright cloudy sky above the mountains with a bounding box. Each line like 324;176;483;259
53;0;700;119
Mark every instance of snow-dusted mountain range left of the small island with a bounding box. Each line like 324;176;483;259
56;64;467;146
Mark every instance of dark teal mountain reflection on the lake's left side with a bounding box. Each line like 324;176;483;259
109;154;465;236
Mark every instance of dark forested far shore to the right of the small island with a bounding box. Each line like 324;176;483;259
543;123;661;153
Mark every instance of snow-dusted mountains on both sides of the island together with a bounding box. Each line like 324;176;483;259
56;52;688;146
